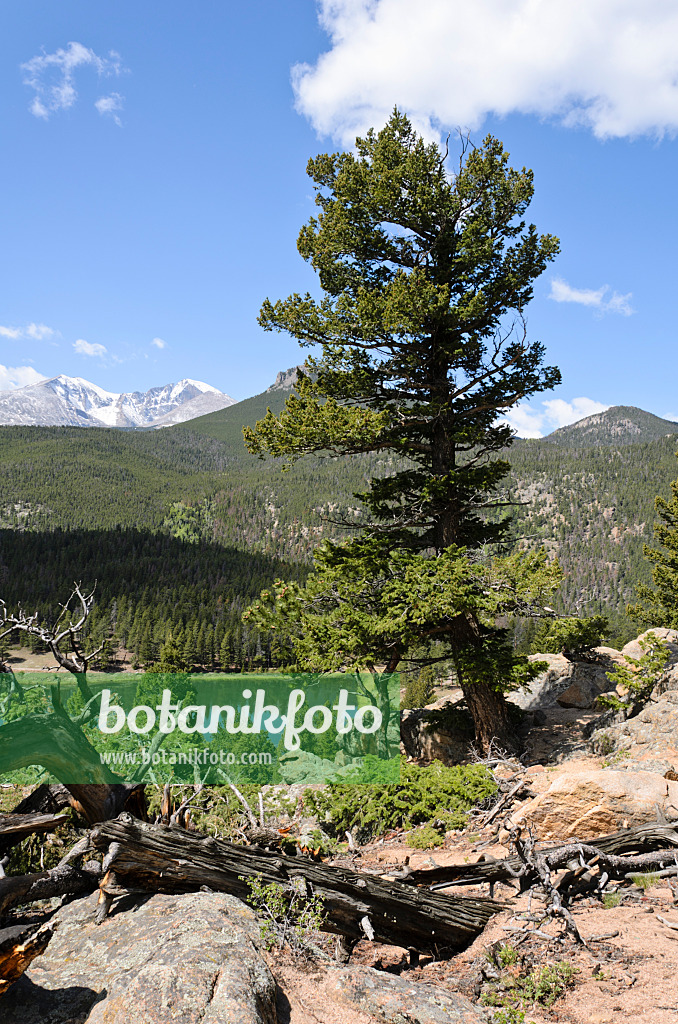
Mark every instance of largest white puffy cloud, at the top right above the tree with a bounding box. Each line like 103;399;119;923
292;0;678;145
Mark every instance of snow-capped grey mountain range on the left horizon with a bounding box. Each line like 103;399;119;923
0;374;235;428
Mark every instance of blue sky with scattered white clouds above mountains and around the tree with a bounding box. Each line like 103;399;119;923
0;0;678;435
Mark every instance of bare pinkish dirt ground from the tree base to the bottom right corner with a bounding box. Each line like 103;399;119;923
271;710;678;1024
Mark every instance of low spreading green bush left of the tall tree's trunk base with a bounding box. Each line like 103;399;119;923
304;761;497;839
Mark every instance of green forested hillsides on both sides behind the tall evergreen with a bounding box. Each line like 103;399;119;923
0;390;678;667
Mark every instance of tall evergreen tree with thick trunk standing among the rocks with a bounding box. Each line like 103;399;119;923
245;111;560;748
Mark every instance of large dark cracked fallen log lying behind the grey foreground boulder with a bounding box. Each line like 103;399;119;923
91;813;505;956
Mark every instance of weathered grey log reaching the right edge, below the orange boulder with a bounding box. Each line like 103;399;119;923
409;821;678;889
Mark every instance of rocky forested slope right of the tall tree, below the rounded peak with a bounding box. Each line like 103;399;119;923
509;435;678;632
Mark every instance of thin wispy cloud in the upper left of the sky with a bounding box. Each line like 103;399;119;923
22;43;125;124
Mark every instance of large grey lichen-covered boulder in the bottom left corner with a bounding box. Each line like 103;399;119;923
0;892;277;1024
